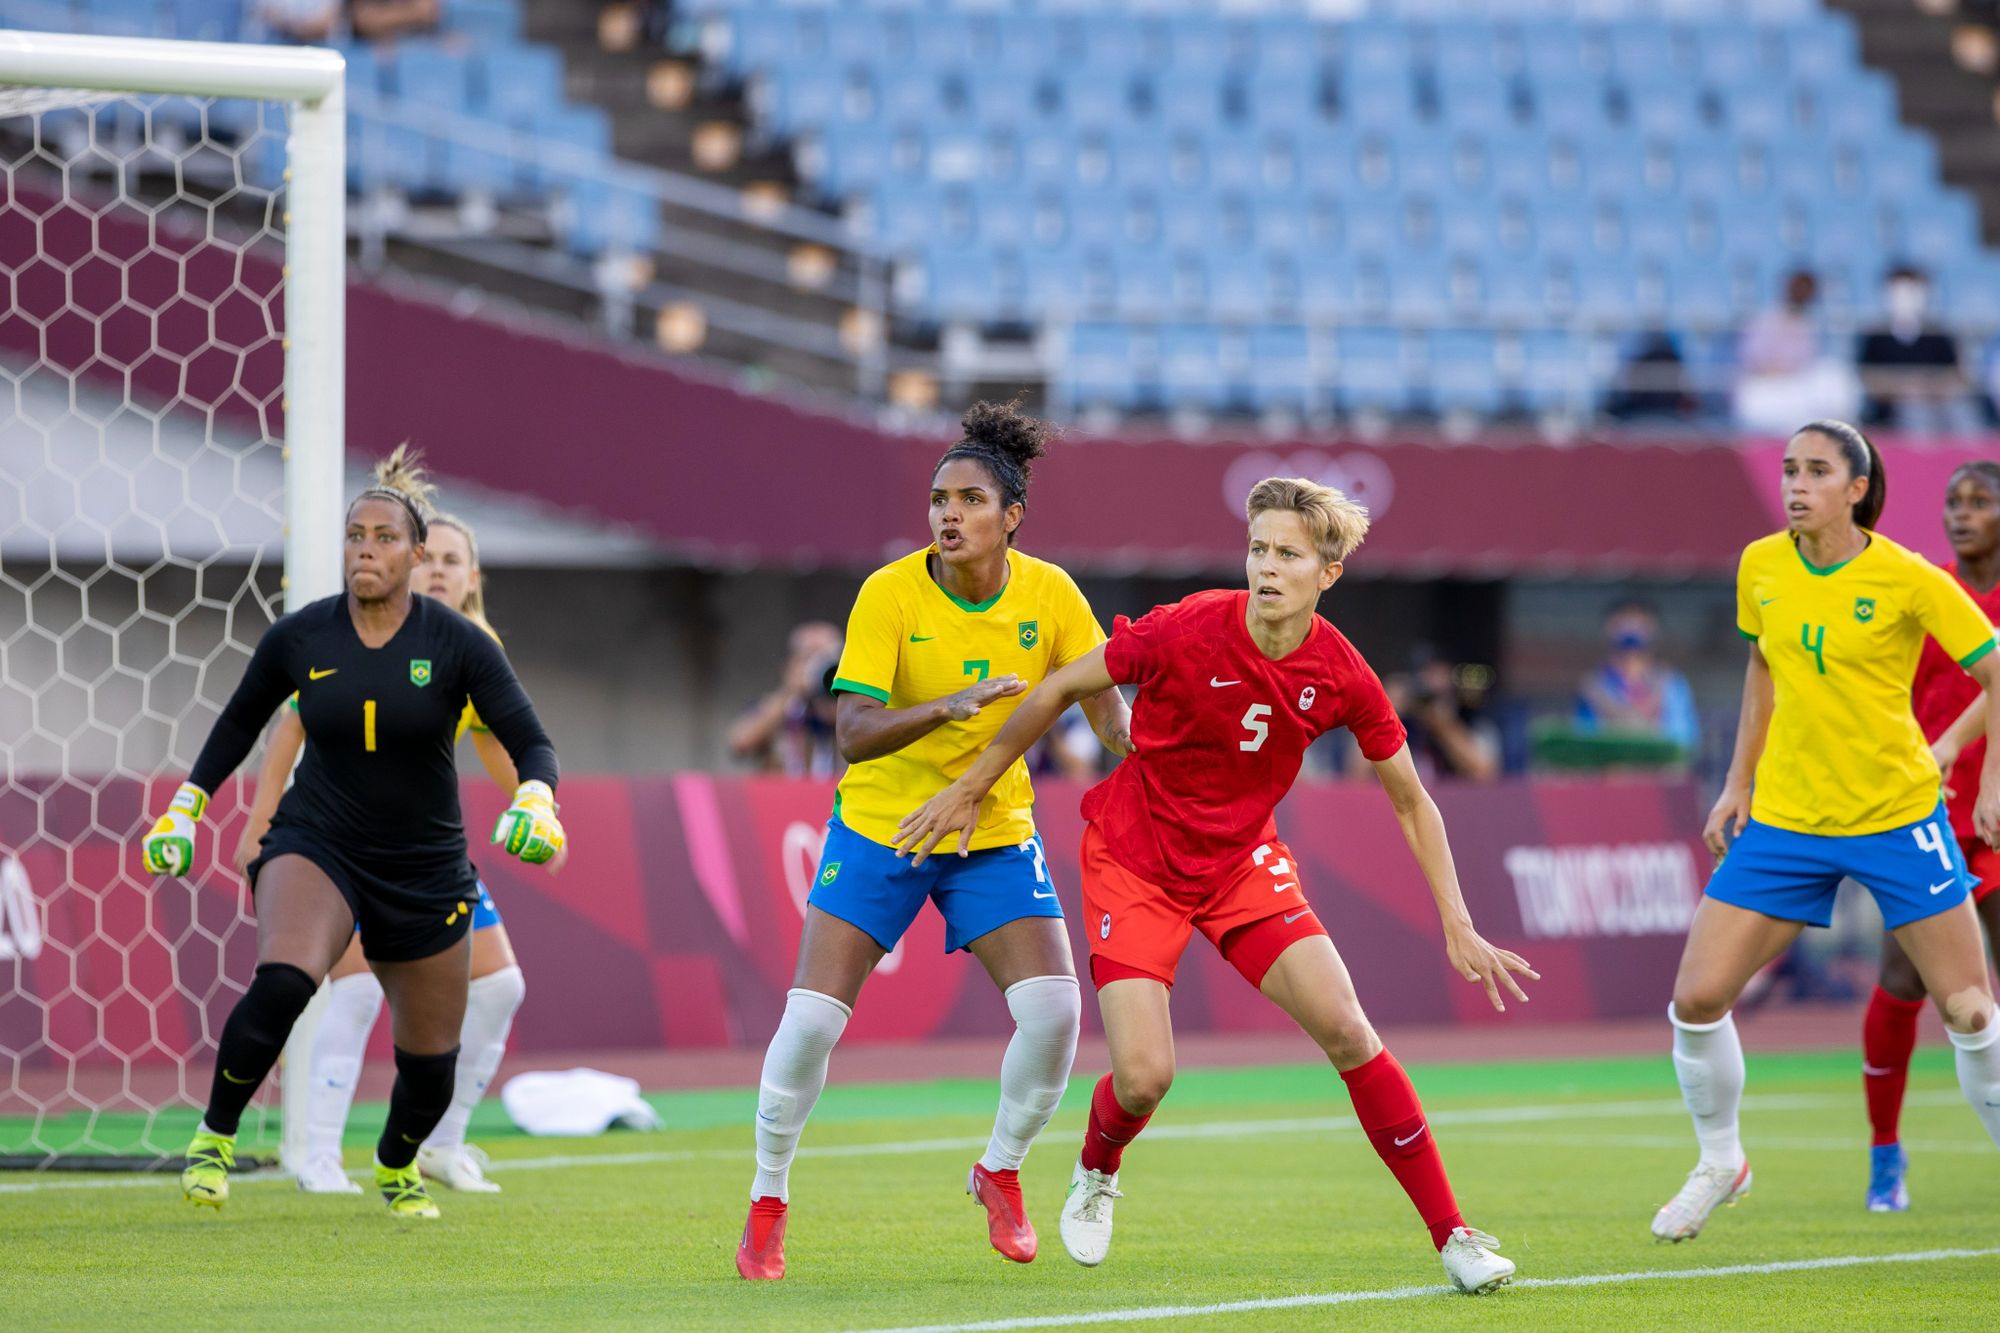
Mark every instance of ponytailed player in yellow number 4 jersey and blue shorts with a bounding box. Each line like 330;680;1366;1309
1652;420;2000;1241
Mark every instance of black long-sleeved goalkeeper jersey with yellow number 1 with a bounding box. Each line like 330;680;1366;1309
188;592;558;871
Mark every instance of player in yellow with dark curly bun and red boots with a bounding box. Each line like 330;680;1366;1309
736;402;1132;1279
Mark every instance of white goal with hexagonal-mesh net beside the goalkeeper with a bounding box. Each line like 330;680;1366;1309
0;32;344;1167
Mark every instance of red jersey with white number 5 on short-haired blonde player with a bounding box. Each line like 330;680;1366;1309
1084;590;1404;891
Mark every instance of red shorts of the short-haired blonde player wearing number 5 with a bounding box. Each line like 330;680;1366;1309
1084;825;1326;987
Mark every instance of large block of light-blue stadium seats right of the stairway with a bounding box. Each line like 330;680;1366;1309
678;0;2000;412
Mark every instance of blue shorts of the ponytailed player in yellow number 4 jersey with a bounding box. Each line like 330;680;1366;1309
1706;801;1978;931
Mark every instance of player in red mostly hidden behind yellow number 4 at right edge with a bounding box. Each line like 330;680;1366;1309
1862;458;2000;1213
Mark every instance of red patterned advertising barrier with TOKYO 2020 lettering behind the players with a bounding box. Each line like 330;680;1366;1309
0;773;1706;1065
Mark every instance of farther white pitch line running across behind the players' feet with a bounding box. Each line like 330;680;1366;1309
0;1089;1990;1195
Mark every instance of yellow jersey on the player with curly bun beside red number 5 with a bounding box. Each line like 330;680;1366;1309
834;546;1104;851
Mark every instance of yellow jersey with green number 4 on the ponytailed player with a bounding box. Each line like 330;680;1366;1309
1736;532;1994;837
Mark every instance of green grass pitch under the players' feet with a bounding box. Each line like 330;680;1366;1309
0;1051;2000;1333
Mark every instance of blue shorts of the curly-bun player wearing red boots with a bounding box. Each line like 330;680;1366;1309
806;819;1062;953
